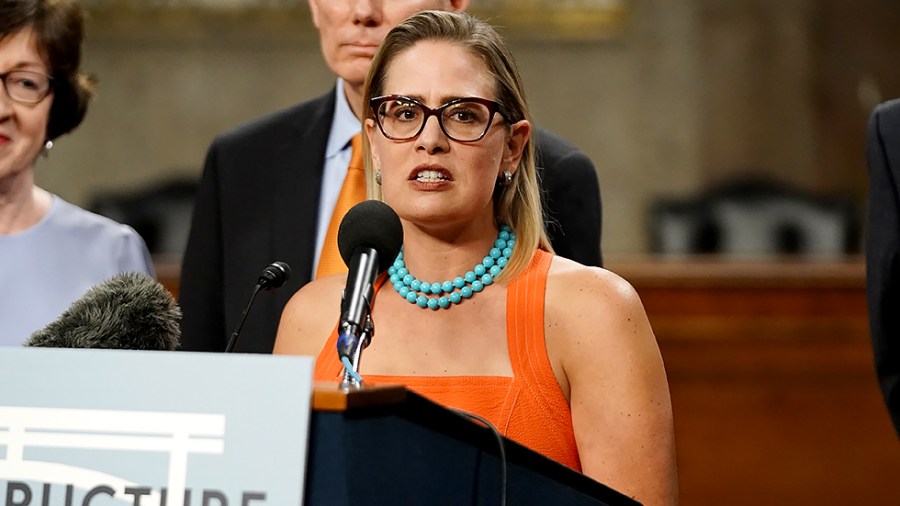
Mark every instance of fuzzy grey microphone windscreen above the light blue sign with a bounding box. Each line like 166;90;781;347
25;272;181;350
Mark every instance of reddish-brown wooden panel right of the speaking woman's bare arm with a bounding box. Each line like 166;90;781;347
609;259;900;506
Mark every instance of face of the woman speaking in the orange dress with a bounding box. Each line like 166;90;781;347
366;41;529;226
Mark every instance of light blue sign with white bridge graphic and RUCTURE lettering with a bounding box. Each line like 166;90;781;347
0;348;313;506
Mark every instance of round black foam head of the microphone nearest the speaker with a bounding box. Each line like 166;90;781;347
338;200;403;272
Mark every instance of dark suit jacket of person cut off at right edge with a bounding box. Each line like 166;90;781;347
866;99;900;434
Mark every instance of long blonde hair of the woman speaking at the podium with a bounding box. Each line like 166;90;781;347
363;11;553;281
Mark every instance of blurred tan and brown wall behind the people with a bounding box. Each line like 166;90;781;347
37;0;900;254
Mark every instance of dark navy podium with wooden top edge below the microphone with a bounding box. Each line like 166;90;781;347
305;383;638;506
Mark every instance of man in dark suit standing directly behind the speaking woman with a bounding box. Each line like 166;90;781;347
179;0;601;353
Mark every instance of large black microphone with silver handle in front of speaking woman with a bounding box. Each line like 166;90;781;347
337;200;403;383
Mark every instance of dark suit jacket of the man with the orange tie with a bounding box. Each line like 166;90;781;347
179;89;601;353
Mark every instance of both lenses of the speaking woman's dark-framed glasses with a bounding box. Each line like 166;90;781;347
378;100;493;142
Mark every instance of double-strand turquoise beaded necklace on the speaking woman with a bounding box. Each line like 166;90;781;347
388;225;516;310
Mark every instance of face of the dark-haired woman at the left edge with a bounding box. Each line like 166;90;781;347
0;28;53;184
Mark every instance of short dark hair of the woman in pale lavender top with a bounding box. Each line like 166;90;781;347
0;0;96;140
